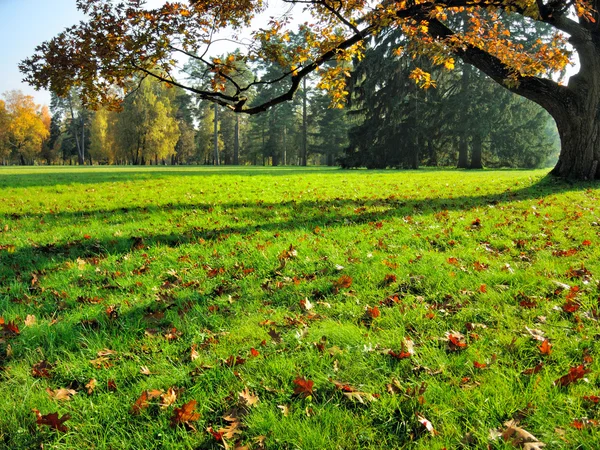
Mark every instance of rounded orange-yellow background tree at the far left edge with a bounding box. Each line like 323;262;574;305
4;91;50;164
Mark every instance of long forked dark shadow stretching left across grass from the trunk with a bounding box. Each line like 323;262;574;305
0;170;594;281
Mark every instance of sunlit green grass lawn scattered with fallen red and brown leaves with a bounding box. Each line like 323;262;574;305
0;167;600;449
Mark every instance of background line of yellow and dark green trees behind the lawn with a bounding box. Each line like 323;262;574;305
0;30;559;168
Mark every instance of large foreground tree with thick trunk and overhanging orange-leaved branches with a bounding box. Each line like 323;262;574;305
21;0;600;179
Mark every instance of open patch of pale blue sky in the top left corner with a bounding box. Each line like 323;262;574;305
0;0;82;104
